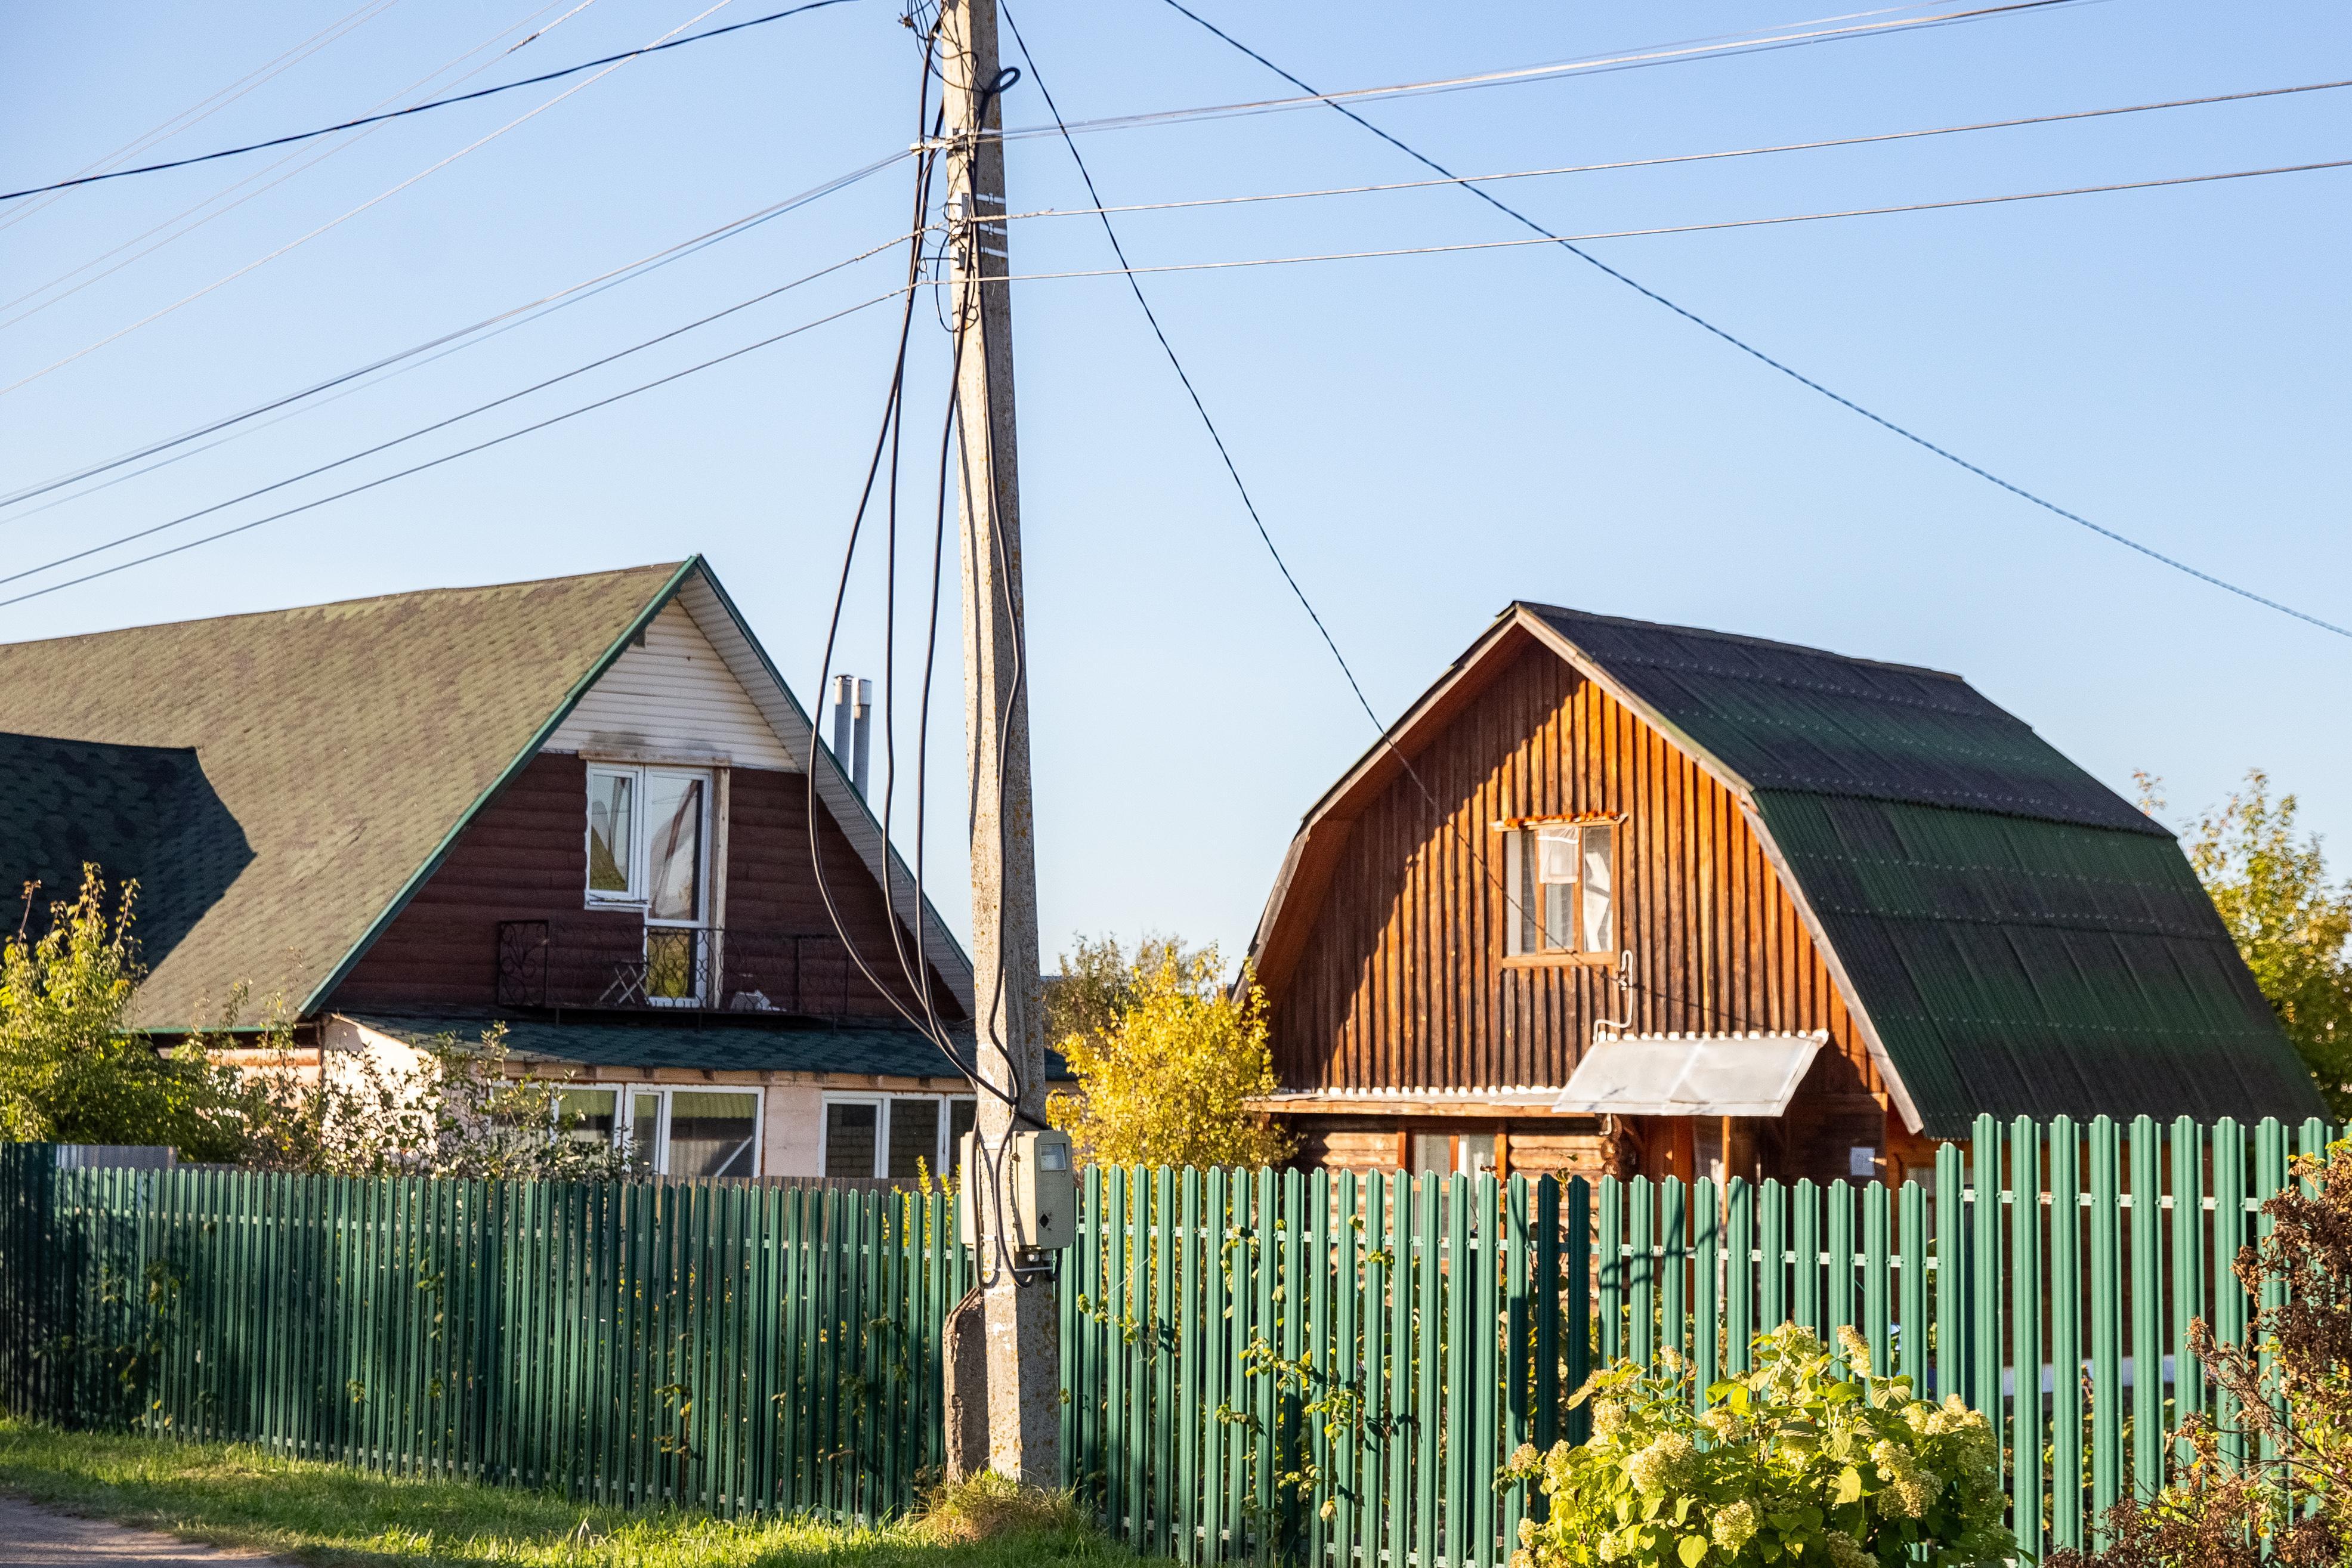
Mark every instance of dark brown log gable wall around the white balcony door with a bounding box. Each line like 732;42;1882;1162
327;752;962;1020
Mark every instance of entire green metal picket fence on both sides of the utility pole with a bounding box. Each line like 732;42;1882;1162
0;1119;2338;1568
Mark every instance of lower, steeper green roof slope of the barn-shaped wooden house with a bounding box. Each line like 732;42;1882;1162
1757;790;2322;1138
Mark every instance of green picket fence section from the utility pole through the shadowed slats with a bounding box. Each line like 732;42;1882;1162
1061;1168;1592;1568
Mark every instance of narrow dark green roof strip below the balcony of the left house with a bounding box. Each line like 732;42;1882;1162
344;1013;1068;1081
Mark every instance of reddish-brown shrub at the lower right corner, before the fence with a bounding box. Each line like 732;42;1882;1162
2046;1143;2352;1568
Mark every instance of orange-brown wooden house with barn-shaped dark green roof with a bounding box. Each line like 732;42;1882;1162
1251;604;2322;1180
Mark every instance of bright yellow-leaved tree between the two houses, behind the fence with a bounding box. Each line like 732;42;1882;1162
1047;941;1291;1166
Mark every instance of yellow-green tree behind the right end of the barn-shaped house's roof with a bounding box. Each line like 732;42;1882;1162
2140;769;2352;1119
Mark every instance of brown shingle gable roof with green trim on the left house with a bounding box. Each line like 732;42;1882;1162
0;557;971;1029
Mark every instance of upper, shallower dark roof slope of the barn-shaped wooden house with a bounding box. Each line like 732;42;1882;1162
1526;604;2171;837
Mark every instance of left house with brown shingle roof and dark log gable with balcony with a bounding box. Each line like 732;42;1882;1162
0;557;1039;1178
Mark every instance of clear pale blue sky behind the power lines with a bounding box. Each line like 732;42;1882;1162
0;0;2352;954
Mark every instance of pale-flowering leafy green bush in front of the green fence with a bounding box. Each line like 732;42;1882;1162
1503;1323;2016;1568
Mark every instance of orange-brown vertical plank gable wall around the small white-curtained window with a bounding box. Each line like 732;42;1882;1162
1268;644;1881;1098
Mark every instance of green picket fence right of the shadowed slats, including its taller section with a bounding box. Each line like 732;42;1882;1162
1594;1117;2342;1556
